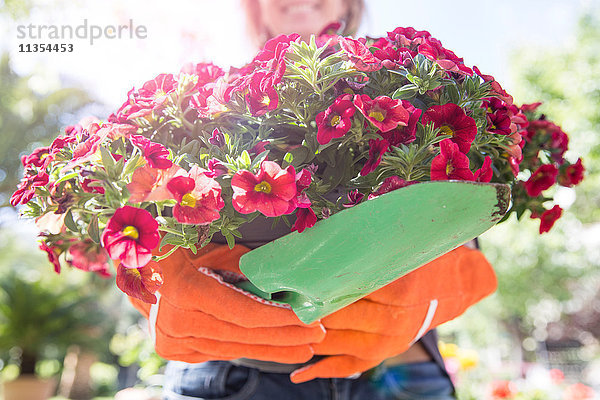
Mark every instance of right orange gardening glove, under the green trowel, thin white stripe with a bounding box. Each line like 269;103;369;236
291;246;497;383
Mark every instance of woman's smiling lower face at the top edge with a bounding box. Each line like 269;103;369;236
258;0;347;40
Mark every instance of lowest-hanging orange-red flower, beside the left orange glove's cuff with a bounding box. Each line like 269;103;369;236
117;261;163;304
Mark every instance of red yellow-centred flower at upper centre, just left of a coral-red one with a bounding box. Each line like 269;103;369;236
315;94;356;144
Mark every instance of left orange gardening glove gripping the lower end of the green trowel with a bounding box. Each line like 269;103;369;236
130;244;325;363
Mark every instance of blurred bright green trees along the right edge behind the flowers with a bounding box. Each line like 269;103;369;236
454;9;600;366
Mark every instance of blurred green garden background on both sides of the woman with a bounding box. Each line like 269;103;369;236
0;0;600;399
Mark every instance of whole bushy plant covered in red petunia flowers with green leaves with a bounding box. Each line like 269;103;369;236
11;28;583;301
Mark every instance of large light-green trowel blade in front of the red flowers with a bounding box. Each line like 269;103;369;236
240;181;510;324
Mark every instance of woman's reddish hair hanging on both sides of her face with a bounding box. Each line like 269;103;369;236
241;0;365;47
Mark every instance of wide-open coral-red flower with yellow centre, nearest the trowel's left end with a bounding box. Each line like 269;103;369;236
231;161;296;217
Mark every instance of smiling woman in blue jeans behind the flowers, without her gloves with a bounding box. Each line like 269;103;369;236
156;0;454;400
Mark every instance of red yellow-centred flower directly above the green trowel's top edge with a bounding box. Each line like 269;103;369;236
431;139;475;181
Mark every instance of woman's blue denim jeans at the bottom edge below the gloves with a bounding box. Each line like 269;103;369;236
163;361;454;400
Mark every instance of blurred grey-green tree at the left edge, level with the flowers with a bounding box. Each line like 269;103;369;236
0;54;90;207
